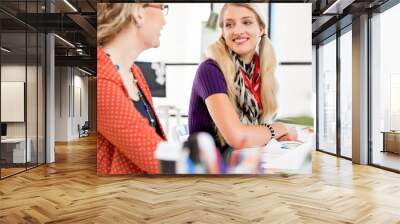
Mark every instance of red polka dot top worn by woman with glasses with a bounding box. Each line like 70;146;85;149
97;49;166;174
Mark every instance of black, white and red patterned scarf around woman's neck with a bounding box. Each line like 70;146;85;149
231;51;262;124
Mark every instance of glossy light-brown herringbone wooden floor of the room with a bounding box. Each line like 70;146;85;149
0;137;400;224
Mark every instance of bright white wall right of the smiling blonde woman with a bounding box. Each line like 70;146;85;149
271;3;315;117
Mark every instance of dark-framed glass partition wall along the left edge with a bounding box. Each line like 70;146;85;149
0;1;46;179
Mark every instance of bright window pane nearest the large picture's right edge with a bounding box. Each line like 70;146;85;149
318;40;336;153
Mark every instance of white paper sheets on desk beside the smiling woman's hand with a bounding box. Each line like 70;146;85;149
261;135;314;173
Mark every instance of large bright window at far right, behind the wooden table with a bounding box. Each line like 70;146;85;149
370;1;400;171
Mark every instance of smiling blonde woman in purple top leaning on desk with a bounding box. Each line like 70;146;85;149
189;3;297;154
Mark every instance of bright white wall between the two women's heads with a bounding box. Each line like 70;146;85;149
137;3;210;122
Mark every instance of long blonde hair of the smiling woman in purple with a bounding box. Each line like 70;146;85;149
206;3;278;144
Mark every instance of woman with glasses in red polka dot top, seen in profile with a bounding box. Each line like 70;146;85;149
97;3;168;174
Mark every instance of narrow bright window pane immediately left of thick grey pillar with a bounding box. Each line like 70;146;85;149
340;30;353;158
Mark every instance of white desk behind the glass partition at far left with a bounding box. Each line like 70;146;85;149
1;138;32;163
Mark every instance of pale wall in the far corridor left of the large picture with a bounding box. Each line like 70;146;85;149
55;67;88;141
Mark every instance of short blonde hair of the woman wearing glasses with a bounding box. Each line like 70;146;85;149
97;3;143;46
